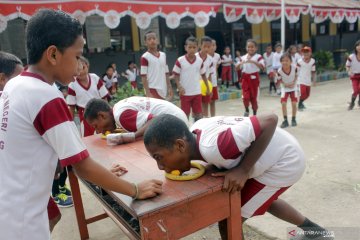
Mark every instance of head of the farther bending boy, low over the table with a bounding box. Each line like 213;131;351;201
84;98;116;133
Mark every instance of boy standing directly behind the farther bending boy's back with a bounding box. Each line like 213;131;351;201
140;31;173;100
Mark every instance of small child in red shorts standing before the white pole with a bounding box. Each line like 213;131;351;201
278;53;298;128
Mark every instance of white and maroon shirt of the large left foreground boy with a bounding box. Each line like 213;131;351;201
0;72;89;240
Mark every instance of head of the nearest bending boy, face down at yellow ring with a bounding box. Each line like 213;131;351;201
144;114;196;173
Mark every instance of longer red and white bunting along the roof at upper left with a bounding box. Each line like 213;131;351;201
0;0;222;32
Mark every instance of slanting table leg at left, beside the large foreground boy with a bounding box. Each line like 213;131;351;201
68;167;89;240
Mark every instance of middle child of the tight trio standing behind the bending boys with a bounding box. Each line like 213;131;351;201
196;36;214;117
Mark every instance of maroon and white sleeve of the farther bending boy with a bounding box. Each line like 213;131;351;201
119;109;153;132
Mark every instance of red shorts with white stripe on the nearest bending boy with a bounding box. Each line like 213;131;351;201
241;178;290;218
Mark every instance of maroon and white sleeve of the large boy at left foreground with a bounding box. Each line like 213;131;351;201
33;98;89;166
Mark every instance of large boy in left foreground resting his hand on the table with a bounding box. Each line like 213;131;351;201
0;9;162;240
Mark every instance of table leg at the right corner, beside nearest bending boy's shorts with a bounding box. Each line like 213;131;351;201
227;193;242;240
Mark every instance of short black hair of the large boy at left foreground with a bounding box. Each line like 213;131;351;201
25;9;83;64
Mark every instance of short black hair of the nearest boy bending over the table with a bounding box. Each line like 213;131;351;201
144;114;194;149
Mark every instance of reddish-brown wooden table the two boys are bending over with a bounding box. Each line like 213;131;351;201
69;135;242;240
